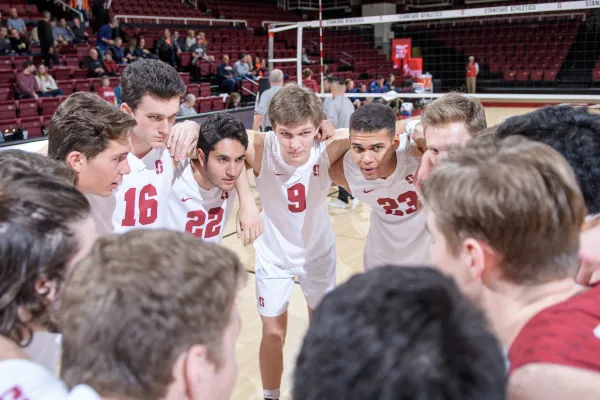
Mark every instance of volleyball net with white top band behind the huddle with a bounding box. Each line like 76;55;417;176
269;0;600;104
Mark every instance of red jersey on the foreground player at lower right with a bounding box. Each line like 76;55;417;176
508;285;600;375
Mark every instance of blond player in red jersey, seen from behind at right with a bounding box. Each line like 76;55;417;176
423;136;600;400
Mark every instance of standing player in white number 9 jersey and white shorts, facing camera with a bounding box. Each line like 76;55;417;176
246;84;349;399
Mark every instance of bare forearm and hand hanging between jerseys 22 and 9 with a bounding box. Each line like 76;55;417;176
235;169;262;246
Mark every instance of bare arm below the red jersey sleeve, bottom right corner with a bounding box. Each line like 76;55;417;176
507;363;600;400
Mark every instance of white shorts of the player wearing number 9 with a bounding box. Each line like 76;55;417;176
255;246;336;317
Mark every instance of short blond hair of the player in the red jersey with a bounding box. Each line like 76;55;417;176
423;136;585;284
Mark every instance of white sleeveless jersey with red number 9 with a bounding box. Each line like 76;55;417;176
254;132;335;268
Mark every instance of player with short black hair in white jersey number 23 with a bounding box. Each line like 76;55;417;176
331;104;430;270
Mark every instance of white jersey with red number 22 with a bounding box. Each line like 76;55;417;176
167;160;236;244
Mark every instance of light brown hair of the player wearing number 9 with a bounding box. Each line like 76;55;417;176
269;83;323;128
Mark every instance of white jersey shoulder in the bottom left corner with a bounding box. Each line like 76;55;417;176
0;359;101;400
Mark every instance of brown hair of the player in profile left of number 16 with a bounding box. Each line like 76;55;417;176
48;92;136;161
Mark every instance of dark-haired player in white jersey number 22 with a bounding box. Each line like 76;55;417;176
167;114;254;243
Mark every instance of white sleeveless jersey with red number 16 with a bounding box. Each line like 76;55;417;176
88;149;174;234
